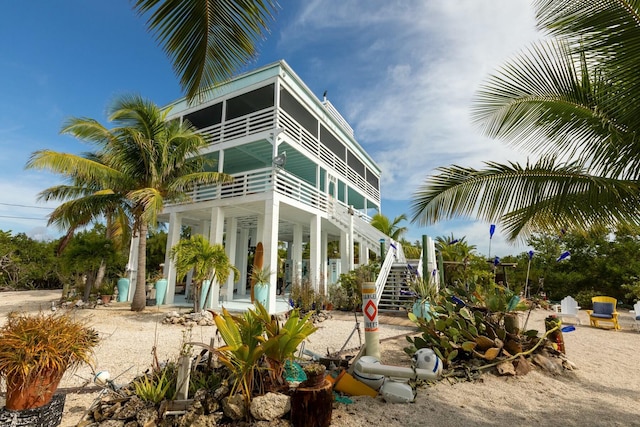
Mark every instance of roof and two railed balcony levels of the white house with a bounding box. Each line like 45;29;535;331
169;61;380;210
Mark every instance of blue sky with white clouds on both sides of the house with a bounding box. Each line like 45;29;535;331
0;0;541;256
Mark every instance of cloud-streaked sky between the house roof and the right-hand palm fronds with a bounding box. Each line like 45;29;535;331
279;0;541;254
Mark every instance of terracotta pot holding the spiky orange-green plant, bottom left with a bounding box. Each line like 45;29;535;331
5;373;62;411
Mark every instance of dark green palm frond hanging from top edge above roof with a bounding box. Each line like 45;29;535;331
133;0;277;100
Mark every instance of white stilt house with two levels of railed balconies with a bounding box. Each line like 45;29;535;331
160;61;386;312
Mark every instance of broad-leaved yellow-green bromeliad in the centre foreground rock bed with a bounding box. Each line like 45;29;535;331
213;303;317;402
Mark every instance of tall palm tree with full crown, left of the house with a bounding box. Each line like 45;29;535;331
27;96;231;311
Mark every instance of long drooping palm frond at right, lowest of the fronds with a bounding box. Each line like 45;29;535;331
412;158;640;240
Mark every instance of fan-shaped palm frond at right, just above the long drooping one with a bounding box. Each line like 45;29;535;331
472;37;640;176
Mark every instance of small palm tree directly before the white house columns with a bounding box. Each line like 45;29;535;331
171;234;240;311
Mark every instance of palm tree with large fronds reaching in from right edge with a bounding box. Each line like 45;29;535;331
412;0;640;240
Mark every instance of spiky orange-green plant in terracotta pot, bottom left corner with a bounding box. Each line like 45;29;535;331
0;312;98;411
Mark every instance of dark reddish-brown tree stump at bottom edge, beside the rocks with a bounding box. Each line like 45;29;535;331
291;379;333;427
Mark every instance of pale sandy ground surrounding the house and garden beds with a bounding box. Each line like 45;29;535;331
0;291;640;427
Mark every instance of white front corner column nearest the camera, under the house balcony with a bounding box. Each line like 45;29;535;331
258;194;280;314
